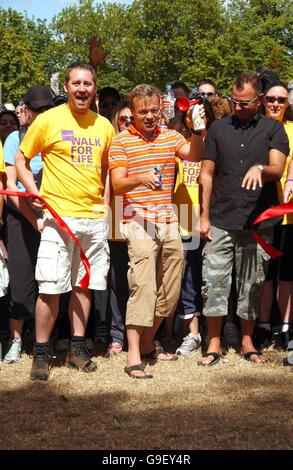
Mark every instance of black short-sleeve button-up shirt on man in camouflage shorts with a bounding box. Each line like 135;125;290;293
204;113;289;230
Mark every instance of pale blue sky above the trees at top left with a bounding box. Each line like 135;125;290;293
0;0;131;21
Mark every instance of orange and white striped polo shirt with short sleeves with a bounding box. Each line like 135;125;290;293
109;126;187;222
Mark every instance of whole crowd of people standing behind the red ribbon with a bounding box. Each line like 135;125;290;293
0;53;293;381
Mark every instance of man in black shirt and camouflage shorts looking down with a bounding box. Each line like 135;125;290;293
199;73;289;365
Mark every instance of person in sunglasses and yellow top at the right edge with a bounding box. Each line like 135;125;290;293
254;81;293;350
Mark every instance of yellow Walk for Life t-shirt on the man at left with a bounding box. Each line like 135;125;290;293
20;104;115;219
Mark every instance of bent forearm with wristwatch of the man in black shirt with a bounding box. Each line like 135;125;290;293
242;149;286;190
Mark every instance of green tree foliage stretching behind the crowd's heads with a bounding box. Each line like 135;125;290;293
0;0;293;101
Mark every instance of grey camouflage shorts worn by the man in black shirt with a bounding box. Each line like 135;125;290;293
202;227;273;320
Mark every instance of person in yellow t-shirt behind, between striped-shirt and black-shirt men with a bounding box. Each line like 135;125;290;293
169;100;215;356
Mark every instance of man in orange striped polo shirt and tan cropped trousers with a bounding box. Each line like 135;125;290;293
109;85;204;379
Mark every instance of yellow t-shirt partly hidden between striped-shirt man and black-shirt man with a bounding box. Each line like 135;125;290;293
174;158;201;237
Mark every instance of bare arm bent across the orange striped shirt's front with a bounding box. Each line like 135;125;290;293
111;166;160;195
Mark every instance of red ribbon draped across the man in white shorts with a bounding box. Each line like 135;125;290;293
0;190;90;289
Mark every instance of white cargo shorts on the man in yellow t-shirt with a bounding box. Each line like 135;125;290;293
36;214;109;294
